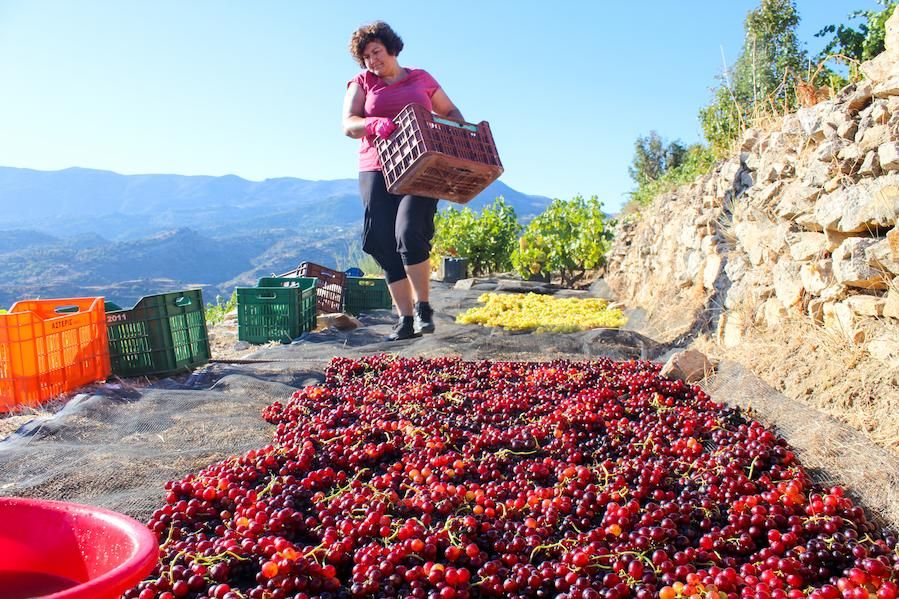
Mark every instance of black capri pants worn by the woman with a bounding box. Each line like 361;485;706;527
359;171;437;283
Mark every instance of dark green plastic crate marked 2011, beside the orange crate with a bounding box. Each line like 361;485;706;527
106;289;211;376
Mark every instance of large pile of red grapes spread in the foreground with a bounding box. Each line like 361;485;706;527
125;355;899;599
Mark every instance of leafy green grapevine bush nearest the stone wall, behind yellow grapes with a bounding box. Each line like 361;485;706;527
512;196;612;286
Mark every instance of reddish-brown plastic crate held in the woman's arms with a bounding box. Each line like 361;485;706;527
375;104;503;204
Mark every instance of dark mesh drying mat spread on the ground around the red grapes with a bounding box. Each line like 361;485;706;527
0;281;899;524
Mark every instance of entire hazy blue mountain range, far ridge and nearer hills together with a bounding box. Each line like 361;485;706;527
0;167;550;308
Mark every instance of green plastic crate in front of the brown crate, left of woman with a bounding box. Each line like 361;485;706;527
237;277;316;344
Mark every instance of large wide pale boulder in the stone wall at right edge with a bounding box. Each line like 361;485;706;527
815;174;899;233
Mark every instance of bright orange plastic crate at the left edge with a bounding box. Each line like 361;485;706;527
0;297;111;412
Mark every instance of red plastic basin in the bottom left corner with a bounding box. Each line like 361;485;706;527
0;497;159;599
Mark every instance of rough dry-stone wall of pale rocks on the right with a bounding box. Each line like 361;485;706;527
605;11;899;368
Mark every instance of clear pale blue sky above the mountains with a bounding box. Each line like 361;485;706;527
0;0;877;211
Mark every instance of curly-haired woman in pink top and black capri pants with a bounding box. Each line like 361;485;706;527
343;21;465;341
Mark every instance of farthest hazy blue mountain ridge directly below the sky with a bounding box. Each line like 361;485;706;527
0;167;550;240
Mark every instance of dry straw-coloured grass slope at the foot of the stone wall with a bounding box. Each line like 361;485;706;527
694;315;899;454
